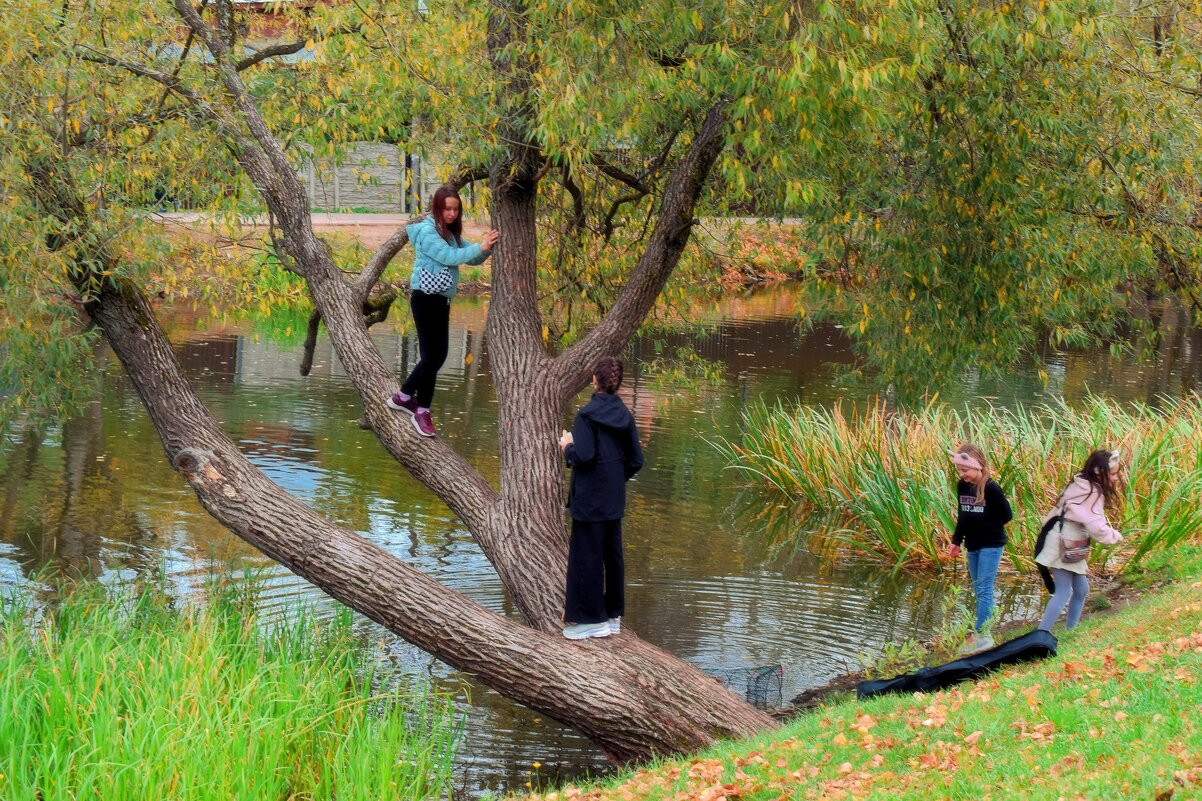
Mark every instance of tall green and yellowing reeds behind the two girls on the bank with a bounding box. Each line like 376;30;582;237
716;397;1202;572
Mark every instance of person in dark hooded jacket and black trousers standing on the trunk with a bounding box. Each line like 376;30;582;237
559;357;643;640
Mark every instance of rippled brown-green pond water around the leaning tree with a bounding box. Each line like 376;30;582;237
0;287;1202;796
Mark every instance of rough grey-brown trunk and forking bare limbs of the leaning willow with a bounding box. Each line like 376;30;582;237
75;0;774;759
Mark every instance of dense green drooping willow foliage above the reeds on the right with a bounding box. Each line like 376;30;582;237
764;0;1202;387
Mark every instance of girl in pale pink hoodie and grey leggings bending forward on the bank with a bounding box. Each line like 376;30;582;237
1035;451;1123;631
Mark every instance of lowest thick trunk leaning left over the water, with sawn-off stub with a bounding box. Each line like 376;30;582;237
79;271;774;759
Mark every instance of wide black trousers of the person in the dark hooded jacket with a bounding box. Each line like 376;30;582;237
564;520;626;623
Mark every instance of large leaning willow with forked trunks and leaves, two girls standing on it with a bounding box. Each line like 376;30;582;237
0;0;1197;758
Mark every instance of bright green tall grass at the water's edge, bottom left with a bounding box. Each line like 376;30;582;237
0;574;454;801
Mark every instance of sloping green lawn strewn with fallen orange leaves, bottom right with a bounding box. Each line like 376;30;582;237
521;547;1202;801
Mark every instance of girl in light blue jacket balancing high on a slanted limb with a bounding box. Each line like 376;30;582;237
388;186;499;437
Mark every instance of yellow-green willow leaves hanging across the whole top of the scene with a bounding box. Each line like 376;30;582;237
0;0;1202;430
